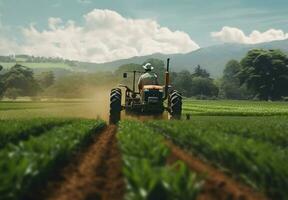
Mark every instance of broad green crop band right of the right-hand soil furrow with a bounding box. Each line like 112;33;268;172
149;120;288;199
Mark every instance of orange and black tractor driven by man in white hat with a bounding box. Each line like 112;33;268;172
110;58;182;123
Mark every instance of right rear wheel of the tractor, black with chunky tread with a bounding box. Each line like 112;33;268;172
168;90;182;119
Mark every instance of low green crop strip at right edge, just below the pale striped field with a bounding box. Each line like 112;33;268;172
164;116;288;148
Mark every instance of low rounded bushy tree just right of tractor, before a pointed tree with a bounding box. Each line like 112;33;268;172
191;77;219;97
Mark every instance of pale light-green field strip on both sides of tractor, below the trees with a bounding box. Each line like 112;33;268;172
0;99;288;120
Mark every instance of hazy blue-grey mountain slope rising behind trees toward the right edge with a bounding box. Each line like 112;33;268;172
88;40;288;77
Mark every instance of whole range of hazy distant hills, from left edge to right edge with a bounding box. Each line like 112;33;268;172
0;40;288;77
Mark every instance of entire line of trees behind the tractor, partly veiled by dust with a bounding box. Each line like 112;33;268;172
0;49;288;100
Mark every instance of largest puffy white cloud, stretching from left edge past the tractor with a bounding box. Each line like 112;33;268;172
0;9;199;62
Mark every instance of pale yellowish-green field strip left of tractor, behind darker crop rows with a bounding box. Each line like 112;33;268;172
0;100;108;120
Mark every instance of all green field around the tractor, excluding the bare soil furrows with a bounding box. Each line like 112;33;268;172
0;99;288;200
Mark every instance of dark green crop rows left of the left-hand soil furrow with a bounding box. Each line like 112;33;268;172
0;119;104;199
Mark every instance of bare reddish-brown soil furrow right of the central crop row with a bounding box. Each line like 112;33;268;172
166;141;267;200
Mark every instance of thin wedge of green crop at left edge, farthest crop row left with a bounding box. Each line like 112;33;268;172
0;118;73;149
